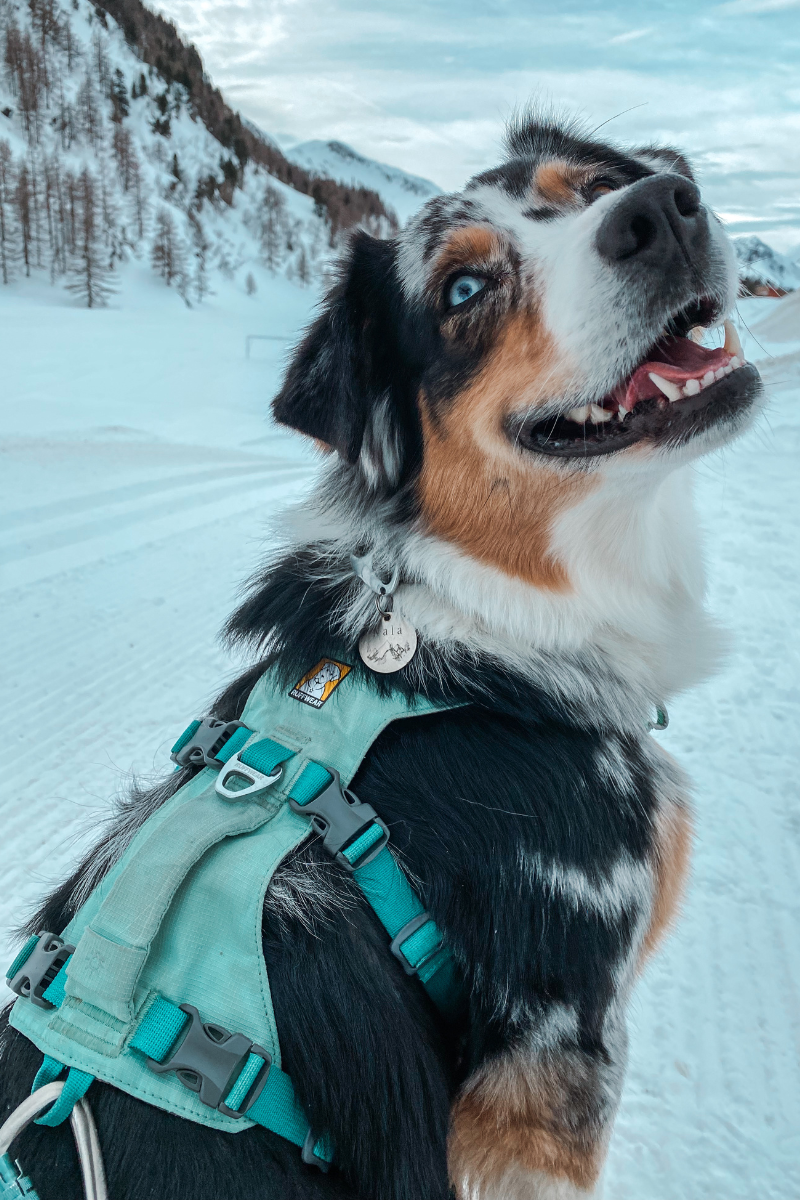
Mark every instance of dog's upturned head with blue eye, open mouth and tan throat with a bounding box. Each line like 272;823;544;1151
275;120;760;588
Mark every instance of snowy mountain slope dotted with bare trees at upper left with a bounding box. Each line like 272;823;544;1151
0;0;397;307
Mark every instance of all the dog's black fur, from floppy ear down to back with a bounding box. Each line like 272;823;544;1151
0;114;681;1200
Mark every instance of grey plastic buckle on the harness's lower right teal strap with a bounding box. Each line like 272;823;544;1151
146;1004;272;1121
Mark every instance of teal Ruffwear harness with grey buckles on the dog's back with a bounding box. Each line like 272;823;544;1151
8;659;459;1170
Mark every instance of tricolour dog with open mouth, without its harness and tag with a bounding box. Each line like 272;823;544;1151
0;115;762;1200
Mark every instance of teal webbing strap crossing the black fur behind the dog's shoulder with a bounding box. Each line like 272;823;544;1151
289;762;461;1014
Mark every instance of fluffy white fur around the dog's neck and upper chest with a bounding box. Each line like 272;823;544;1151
283;466;722;728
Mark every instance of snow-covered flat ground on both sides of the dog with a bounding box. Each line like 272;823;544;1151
0;278;800;1200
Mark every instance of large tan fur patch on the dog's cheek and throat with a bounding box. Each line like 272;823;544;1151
420;313;595;590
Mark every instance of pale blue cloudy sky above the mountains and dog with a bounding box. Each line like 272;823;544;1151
151;0;800;253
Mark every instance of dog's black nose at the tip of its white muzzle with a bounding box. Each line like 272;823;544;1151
596;174;708;265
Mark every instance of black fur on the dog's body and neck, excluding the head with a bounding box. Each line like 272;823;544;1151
0;549;654;1200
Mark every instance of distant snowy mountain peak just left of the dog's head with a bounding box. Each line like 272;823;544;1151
284;142;441;224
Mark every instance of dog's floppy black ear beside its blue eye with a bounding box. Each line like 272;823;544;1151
272;232;415;488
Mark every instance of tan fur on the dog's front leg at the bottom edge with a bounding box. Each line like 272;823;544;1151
447;1056;606;1195
